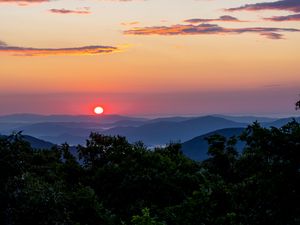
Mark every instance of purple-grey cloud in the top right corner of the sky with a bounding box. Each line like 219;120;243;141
227;0;300;12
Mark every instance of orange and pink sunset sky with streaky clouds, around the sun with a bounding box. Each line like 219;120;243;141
0;0;300;116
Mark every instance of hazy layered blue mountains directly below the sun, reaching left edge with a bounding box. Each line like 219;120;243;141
0;114;148;145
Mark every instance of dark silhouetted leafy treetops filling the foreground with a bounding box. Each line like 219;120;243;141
0;118;300;225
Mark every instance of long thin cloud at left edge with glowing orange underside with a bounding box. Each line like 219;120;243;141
0;44;121;56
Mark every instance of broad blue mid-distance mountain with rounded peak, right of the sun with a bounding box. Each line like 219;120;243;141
103;116;246;146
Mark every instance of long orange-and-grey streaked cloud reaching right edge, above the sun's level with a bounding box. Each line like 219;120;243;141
124;23;300;39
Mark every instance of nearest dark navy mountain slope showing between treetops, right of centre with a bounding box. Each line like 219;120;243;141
181;128;244;161
